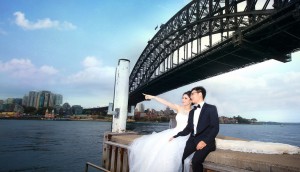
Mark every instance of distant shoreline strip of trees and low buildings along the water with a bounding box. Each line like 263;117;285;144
0;106;300;125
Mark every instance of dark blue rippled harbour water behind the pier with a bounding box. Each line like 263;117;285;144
0;120;300;172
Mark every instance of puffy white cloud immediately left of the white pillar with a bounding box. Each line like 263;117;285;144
62;56;115;107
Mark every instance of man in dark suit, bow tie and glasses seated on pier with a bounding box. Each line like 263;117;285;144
173;86;219;172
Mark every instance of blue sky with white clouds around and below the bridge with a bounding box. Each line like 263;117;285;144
0;0;300;122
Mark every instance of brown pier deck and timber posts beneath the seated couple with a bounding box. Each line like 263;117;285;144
103;133;300;172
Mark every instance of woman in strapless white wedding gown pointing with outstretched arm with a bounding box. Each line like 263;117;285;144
129;91;192;172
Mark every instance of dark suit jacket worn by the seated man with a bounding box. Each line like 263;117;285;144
174;103;219;145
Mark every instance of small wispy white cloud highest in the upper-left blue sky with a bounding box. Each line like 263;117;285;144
14;11;76;30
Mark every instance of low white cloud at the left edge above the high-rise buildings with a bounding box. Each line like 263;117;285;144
0;59;58;79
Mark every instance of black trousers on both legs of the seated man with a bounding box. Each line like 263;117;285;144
182;137;216;172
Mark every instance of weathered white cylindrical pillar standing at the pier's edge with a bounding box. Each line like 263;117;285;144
112;59;130;133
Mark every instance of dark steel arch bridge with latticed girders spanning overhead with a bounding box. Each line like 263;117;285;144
129;0;300;105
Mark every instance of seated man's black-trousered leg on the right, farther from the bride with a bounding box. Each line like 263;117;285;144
192;144;216;172
